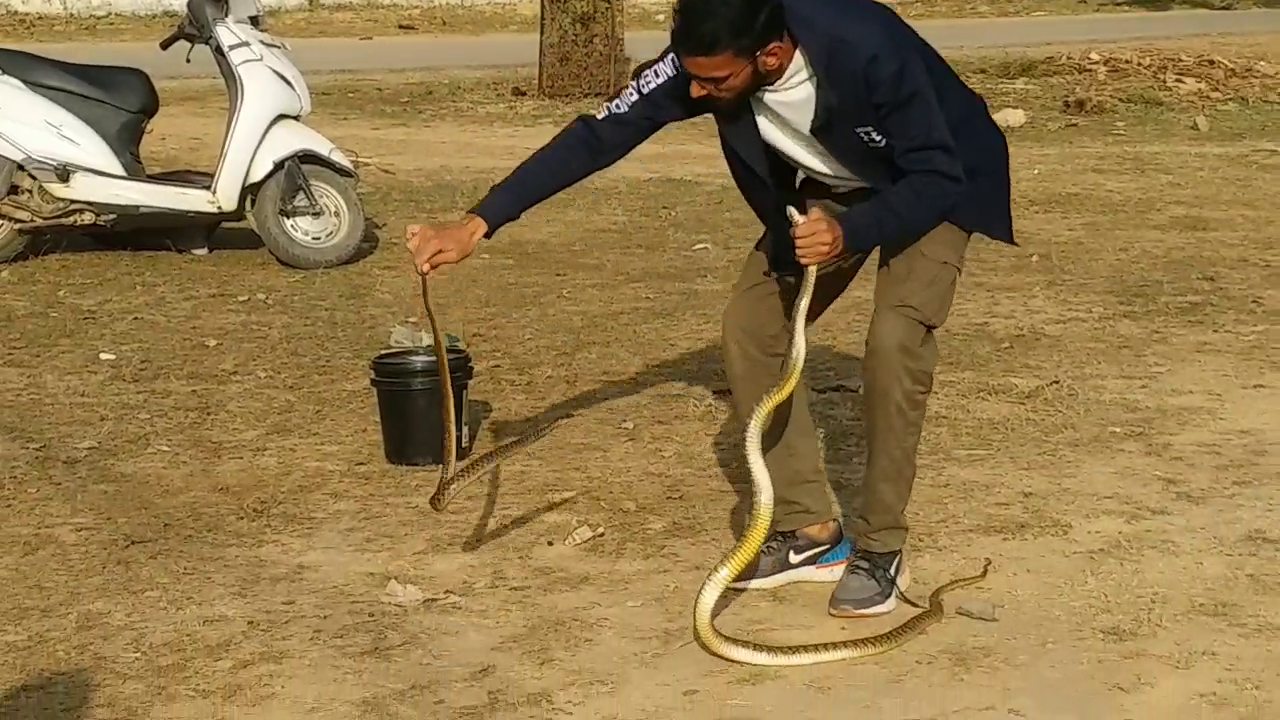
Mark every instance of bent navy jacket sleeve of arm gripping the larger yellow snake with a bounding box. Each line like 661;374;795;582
838;42;965;251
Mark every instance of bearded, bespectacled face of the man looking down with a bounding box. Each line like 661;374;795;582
680;42;791;114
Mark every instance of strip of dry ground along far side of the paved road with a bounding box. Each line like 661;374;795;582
0;0;1259;42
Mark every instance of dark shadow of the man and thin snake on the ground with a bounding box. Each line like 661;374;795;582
462;343;865;594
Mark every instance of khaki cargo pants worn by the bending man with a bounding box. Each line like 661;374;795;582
722;184;969;552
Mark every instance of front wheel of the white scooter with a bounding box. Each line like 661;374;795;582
250;163;365;270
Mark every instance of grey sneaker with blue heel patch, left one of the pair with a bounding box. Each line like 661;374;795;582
728;530;852;591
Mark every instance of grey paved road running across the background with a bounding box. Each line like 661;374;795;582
10;10;1280;78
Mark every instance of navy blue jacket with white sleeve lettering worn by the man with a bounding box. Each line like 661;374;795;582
471;0;1015;274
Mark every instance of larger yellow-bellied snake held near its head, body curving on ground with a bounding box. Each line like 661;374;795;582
694;208;991;665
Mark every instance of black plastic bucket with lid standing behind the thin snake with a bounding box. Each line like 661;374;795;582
369;347;474;465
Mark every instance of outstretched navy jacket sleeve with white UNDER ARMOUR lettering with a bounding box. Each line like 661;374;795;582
468;49;698;237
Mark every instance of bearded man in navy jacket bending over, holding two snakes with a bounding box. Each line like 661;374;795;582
407;0;1015;618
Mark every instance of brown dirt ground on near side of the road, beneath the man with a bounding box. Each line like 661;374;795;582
0;37;1280;720
